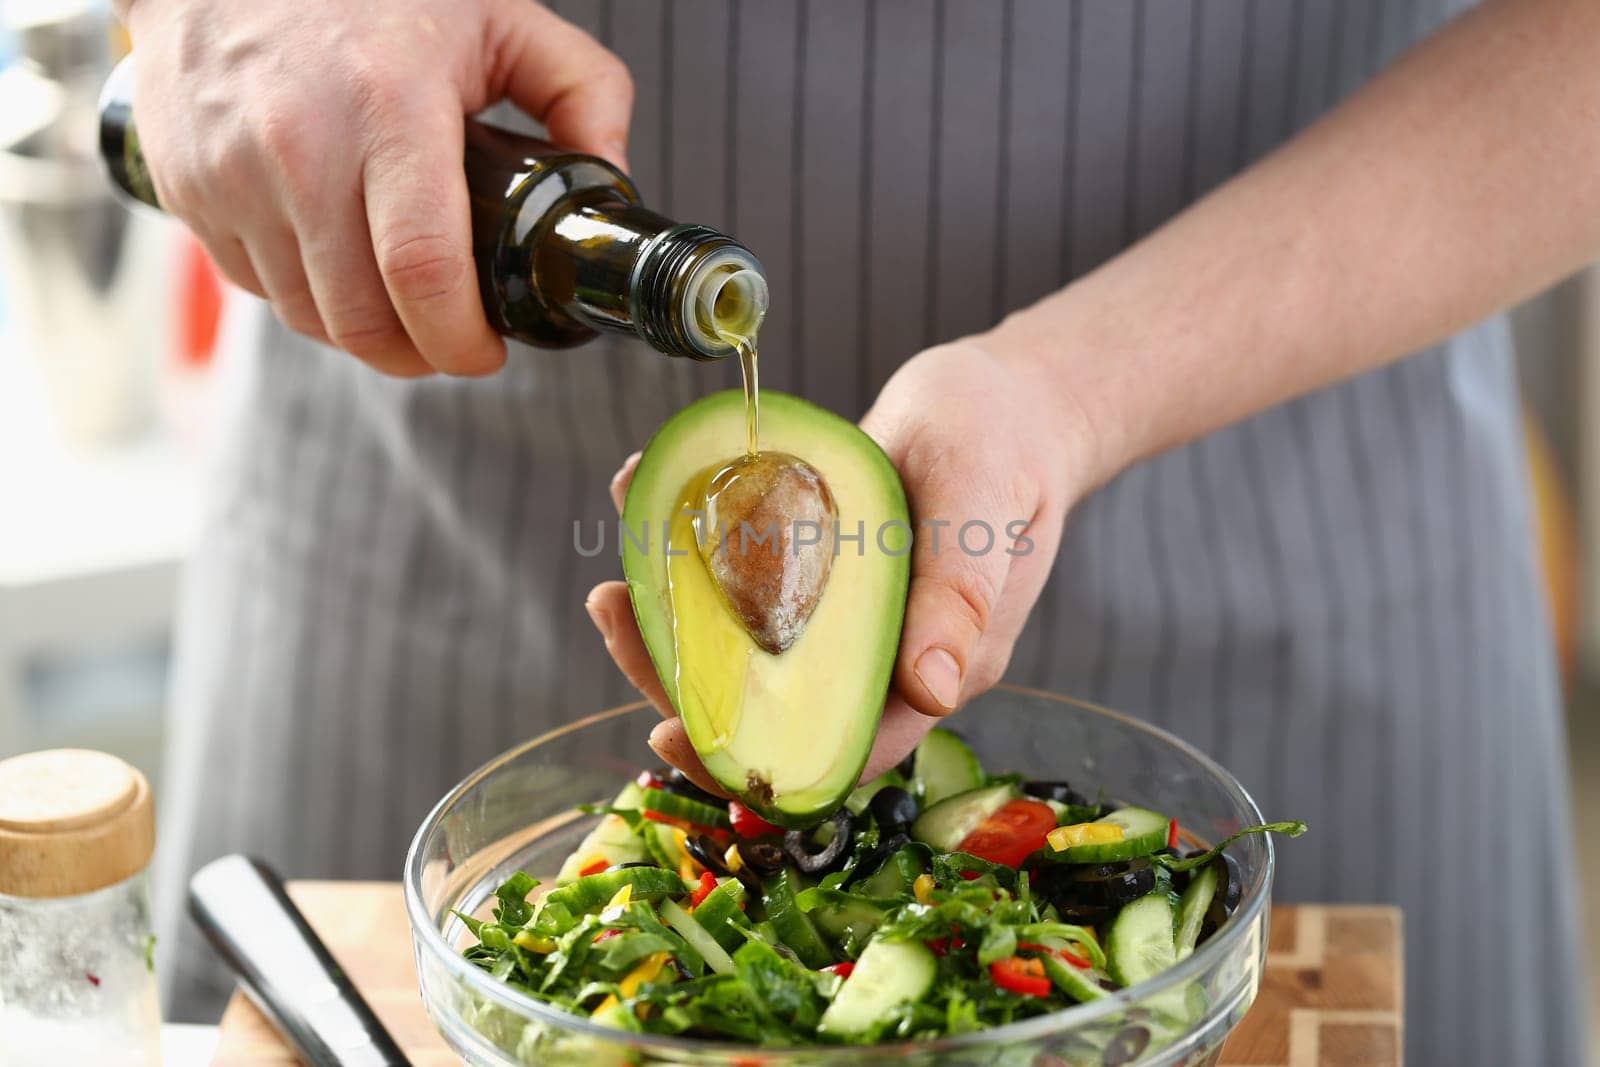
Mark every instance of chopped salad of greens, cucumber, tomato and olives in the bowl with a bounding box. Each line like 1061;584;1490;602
459;729;1304;1062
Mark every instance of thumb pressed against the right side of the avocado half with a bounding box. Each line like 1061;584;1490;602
894;467;1011;715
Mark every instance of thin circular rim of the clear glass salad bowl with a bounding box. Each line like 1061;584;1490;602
403;683;1277;1056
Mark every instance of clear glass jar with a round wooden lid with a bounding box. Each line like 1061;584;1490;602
0;749;162;1067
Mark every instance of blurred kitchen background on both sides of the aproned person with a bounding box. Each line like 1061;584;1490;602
0;0;1600;1062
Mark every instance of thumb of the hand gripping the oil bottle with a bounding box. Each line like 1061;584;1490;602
491;0;634;170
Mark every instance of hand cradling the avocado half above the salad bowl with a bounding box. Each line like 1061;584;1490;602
587;342;1093;792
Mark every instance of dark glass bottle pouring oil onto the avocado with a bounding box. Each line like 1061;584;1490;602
101;59;766;370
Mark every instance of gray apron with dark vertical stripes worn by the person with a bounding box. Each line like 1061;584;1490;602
150;0;1581;1065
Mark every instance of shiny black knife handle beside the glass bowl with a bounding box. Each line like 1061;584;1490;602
189;856;410;1067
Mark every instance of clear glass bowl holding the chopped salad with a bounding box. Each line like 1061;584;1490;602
405;686;1274;1067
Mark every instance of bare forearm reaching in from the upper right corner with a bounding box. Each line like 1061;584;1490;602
978;0;1600;483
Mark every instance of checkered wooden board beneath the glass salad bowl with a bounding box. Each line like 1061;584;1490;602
211;881;1403;1067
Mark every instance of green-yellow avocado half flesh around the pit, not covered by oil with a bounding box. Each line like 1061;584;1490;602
619;390;912;829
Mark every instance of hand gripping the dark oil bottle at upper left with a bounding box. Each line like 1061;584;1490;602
125;0;634;376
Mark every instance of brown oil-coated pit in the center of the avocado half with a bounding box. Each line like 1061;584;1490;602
696;451;838;656
